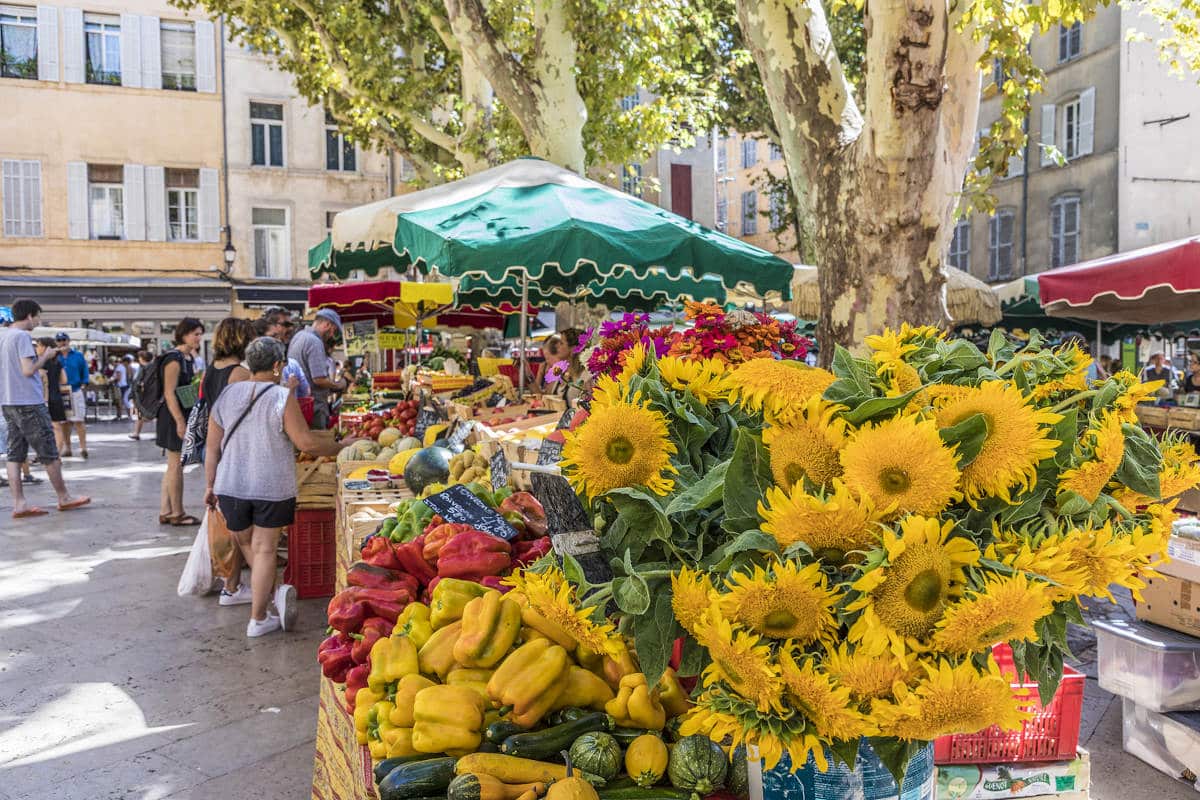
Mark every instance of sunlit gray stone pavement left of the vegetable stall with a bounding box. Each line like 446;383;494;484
0;423;325;800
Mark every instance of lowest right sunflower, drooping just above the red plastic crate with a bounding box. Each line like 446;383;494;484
871;660;1030;741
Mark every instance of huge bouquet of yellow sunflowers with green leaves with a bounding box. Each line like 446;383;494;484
562;325;1200;781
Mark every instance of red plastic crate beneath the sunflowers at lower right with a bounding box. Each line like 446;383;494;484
934;644;1086;764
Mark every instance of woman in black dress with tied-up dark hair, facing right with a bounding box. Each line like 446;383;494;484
155;317;204;527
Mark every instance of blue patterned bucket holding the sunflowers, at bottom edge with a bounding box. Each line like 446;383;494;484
749;740;937;800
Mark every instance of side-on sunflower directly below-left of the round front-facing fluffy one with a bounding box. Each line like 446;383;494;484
758;480;881;563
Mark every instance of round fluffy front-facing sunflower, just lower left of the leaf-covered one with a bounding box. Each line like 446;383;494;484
841;416;962;516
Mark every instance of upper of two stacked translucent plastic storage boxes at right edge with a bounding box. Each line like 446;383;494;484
1092;621;1200;711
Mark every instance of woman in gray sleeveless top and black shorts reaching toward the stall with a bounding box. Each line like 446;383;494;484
204;336;350;637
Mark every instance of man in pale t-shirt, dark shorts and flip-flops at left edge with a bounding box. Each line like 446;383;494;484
0;299;91;519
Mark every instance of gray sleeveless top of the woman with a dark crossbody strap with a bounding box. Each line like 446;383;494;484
211;380;296;503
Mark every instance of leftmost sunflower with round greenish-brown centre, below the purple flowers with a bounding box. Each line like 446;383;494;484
562;402;677;499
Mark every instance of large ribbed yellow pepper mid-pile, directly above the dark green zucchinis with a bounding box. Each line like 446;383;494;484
487;639;571;728
